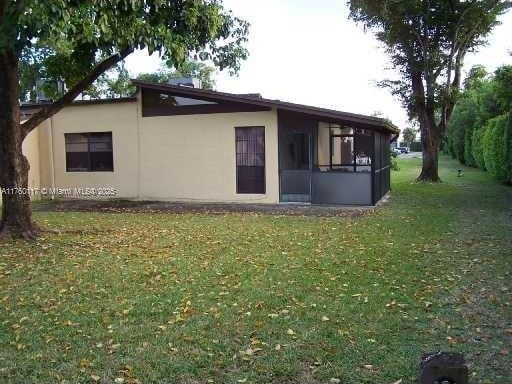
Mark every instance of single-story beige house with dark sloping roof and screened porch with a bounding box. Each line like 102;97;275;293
16;81;398;205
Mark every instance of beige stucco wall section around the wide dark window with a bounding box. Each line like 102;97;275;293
52;102;138;198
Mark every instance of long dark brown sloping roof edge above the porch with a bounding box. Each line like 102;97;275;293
132;80;400;134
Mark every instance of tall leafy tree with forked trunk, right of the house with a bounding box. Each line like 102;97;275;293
349;0;511;182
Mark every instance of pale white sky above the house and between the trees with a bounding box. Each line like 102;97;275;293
126;0;512;129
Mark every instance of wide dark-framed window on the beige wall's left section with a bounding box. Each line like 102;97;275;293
64;132;114;172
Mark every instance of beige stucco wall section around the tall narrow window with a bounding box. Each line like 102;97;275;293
139;111;279;203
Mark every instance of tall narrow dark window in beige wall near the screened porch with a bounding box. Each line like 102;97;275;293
235;127;265;194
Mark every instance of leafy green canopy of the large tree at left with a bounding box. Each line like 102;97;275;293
7;0;248;130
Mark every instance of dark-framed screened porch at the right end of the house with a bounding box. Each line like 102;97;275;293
279;114;391;205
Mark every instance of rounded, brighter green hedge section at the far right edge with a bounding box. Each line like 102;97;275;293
482;115;508;182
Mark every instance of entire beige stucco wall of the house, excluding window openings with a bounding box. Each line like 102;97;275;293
18;101;279;203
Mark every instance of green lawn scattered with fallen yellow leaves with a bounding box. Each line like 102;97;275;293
0;159;512;384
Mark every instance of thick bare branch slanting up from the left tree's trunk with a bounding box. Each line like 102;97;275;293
21;47;133;136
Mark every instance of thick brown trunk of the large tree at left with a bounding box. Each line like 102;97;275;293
0;49;37;239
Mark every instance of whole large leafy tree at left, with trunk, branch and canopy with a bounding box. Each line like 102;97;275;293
0;0;248;238
